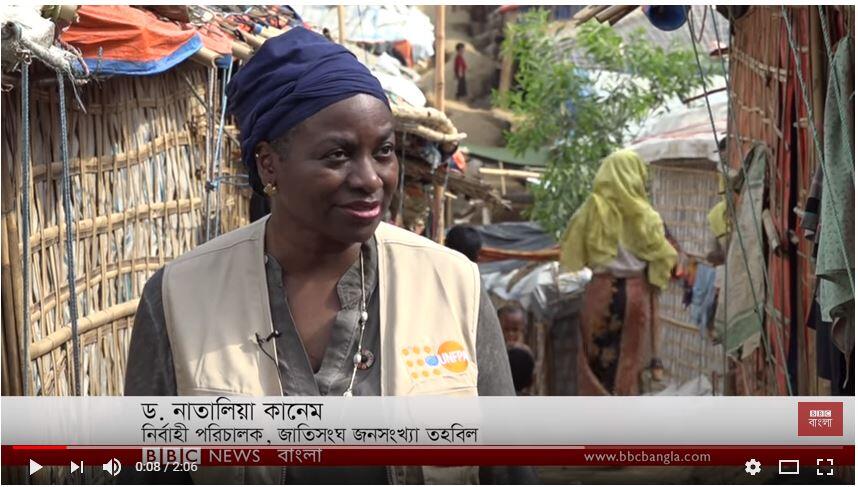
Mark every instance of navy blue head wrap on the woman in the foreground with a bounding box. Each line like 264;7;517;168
227;27;390;193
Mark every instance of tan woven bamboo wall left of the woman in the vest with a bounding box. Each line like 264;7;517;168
2;63;248;395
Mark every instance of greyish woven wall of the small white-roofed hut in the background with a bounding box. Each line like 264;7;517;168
650;164;724;384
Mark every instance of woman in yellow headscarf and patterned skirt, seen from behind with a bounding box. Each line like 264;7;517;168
560;150;677;395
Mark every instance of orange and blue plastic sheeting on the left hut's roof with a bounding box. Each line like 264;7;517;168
61;5;203;75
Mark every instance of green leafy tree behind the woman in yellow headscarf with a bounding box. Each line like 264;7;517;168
494;10;711;236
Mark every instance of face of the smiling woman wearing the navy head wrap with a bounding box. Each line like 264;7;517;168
259;94;399;245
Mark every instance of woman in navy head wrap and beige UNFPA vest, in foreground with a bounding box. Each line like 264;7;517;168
125;28;526;484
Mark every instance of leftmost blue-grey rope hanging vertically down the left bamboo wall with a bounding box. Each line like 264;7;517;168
21;57;30;396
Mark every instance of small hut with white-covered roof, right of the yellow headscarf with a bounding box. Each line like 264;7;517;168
631;96;727;392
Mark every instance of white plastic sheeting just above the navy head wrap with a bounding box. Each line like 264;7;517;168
295;5;435;62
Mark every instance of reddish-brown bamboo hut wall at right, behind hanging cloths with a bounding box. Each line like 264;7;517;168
719;5;855;395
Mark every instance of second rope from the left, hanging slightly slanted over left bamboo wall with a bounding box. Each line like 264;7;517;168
57;71;81;396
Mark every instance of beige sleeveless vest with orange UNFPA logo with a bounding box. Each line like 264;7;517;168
162;217;480;484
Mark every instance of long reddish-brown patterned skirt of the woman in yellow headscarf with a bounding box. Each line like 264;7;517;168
577;274;658;396
